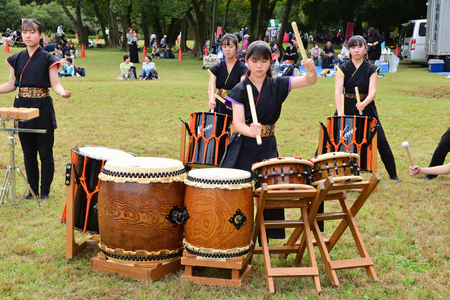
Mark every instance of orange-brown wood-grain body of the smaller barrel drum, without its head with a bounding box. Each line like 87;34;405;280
184;186;254;250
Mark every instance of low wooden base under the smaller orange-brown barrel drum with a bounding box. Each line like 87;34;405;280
181;251;252;287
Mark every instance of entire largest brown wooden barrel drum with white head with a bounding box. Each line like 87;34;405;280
98;157;187;264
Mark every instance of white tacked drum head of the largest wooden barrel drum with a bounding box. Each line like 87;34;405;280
99;157;186;183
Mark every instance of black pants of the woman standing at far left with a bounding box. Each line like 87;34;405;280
19;129;55;195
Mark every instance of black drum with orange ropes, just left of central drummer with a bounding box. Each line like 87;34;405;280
186;112;232;168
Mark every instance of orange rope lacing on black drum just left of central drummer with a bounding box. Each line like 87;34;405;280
186;112;229;165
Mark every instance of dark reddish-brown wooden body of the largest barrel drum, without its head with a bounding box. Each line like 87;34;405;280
98;181;185;252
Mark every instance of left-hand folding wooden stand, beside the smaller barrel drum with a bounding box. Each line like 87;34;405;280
253;183;326;293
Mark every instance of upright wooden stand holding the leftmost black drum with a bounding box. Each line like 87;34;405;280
66;164;100;259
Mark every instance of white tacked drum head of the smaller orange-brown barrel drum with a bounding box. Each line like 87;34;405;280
184;168;253;189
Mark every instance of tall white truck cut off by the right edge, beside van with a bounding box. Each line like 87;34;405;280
425;0;450;61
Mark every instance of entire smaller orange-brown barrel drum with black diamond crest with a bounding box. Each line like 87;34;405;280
184;168;254;258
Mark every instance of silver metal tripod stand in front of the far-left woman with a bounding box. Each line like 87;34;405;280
0;119;46;206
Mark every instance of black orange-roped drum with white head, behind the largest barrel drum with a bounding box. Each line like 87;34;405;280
63;146;135;233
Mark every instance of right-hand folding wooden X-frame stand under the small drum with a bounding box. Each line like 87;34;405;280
285;174;380;285
